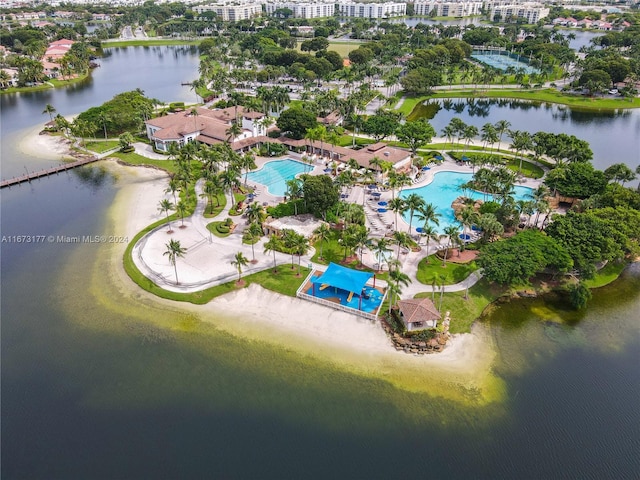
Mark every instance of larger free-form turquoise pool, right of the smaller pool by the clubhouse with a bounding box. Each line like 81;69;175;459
400;172;533;233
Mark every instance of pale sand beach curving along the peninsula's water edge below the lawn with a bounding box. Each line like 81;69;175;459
99;161;495;383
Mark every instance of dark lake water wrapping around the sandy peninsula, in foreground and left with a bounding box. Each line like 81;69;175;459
0;49;640;479
